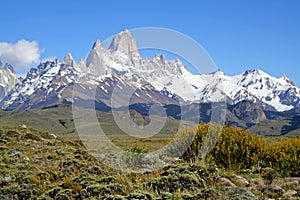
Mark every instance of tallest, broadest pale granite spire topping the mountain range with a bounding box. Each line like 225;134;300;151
109;29;140;59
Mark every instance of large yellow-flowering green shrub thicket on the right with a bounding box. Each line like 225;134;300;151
173;123;300;176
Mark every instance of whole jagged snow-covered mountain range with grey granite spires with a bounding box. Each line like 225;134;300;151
0;30;300;118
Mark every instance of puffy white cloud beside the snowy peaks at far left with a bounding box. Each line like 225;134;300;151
0;40;42;70
